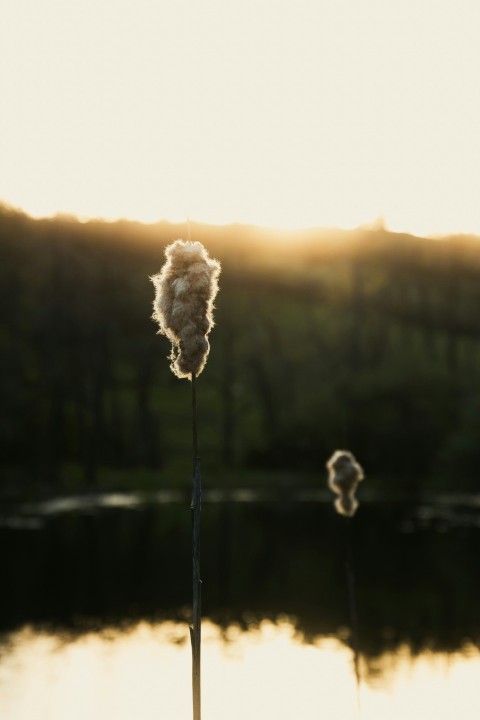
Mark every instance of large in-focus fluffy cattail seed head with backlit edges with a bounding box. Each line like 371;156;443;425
151;240;220;378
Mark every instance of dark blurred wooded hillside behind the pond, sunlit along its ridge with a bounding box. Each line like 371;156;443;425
0;208;480;494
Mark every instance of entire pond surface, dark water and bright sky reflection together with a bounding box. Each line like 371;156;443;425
0;490;480;720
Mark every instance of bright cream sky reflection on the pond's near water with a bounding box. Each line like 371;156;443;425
0;621;480;720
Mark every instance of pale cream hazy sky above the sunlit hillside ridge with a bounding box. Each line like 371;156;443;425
0;0;480;235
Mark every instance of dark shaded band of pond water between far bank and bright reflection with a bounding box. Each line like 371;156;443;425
0;491;480;662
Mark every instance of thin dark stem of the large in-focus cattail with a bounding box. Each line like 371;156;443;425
190;373;202;720
